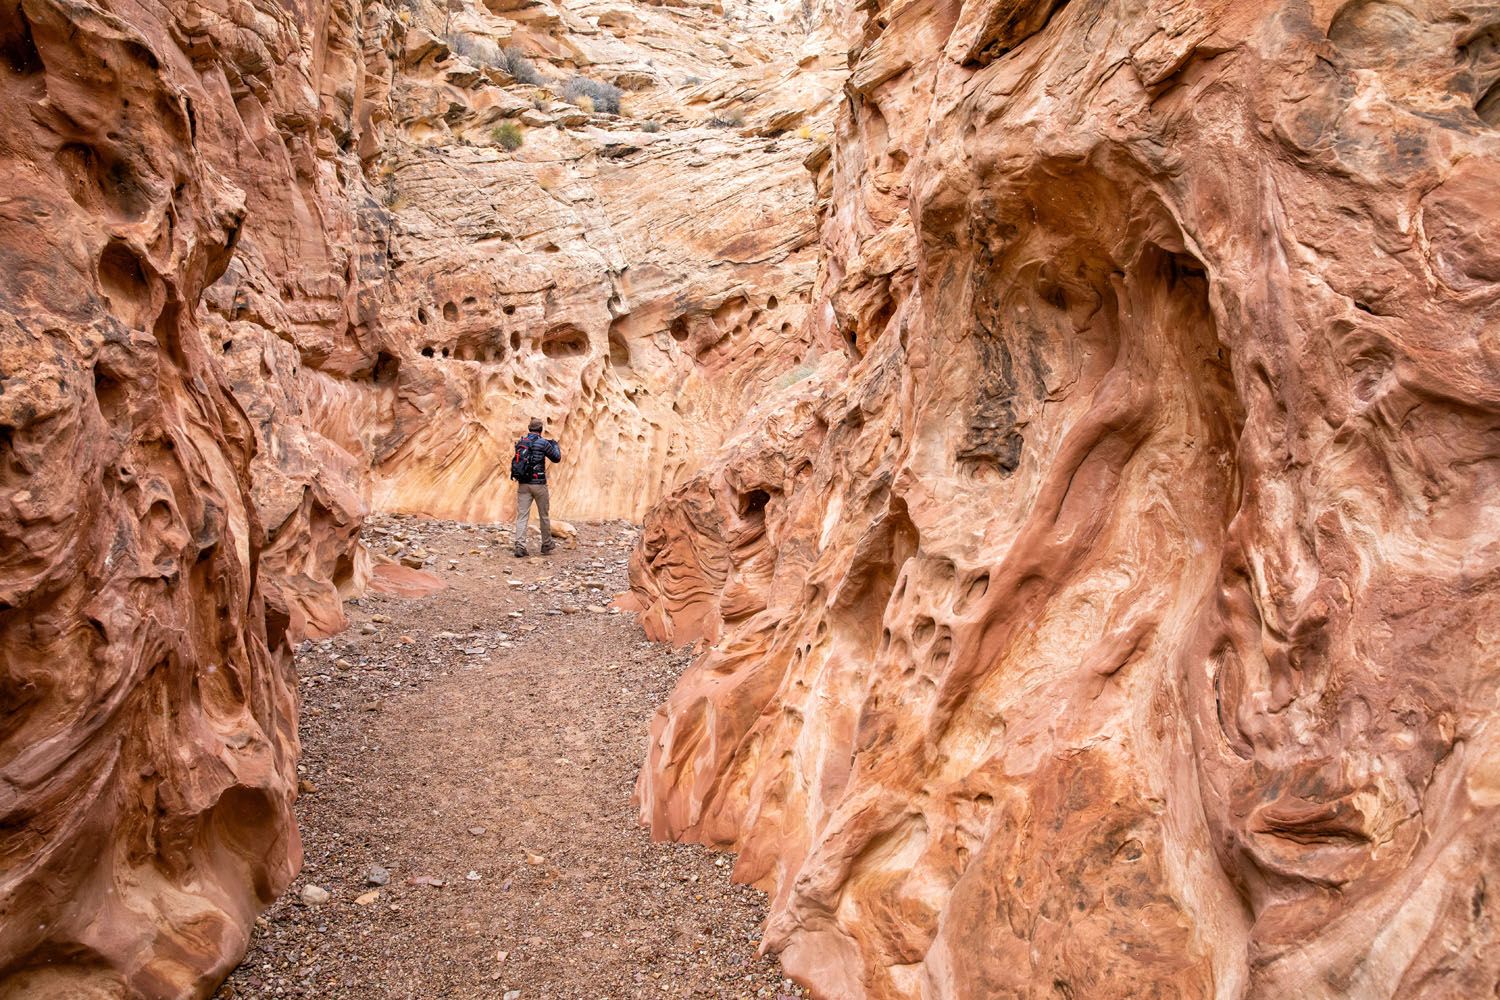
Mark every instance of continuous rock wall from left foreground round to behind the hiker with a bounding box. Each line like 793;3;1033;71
0;0;845;997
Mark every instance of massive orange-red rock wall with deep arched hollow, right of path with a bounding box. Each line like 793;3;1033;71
633;0;1500;999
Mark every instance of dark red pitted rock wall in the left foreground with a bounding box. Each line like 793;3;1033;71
0;0;300;997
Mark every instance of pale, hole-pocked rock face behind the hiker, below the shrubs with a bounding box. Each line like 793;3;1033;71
354;119;816;522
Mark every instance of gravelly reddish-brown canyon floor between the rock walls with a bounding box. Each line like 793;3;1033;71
218;517;803;1000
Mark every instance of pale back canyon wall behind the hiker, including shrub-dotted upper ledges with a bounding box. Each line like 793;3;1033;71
209;0;848;530
